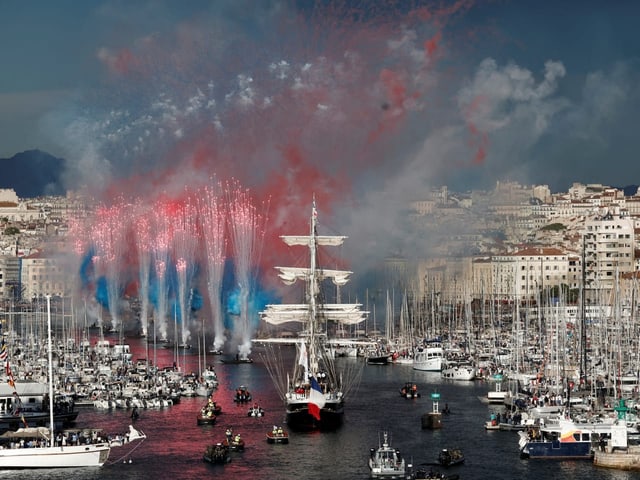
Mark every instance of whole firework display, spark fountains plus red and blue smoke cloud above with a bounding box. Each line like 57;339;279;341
62;0;488;356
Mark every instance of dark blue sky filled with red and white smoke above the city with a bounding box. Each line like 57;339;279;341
0;0;640;270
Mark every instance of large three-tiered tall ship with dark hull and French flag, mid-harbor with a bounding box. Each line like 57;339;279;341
260;199;368;431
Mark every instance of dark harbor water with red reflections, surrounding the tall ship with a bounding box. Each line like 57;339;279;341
0;339;638;480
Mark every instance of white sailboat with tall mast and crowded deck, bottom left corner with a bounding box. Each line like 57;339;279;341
0;296;146;469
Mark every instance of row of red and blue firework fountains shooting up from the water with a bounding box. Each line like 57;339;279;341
72;180;265;355
